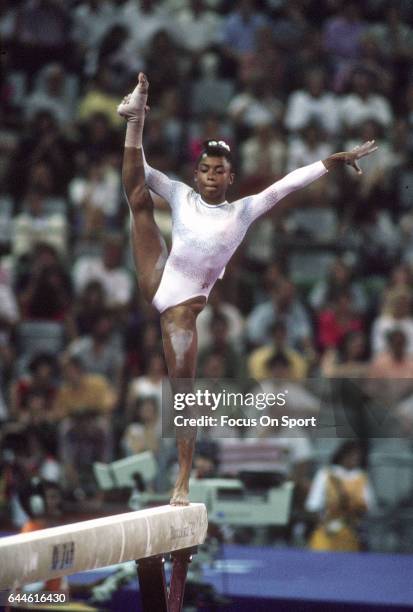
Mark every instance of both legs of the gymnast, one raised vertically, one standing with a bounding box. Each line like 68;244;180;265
118;73;205;505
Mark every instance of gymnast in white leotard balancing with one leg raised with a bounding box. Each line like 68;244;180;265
118;73;377;505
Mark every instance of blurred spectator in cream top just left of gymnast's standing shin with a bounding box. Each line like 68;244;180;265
121;395;161;455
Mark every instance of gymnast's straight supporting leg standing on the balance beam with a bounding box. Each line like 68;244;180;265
161;297;205;506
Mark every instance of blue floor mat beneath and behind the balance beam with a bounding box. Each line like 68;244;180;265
70;545;413;612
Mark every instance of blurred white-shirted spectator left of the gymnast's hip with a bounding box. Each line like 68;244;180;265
73;234;133;309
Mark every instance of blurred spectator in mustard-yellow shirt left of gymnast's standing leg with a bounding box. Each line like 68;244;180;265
53;356;116;420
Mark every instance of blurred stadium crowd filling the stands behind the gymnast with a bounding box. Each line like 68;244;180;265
0;0;413;552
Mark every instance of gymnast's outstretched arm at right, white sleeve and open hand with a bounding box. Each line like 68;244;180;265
245;140;378;221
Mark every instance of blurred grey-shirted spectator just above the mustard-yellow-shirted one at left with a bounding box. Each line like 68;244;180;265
67;309;124;389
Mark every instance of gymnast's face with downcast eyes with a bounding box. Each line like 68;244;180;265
195;155;234;204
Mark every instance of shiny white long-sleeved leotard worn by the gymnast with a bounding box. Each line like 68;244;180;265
144;154;327;312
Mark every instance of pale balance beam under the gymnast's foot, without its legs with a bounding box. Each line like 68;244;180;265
0;504;208;589
